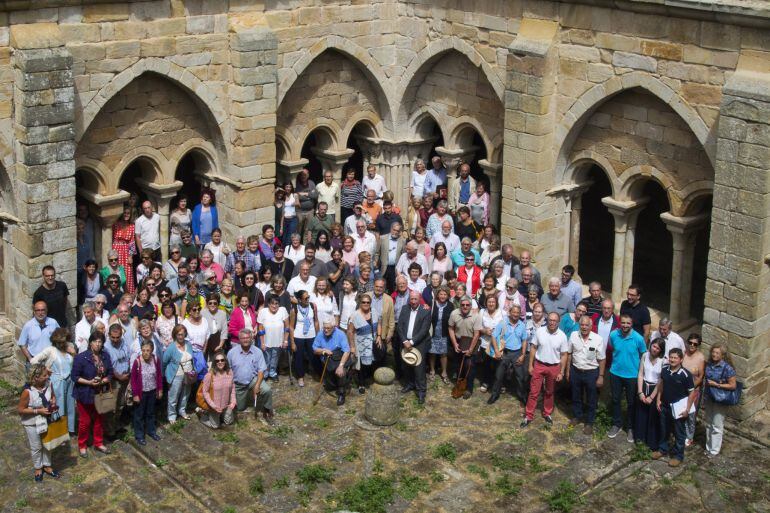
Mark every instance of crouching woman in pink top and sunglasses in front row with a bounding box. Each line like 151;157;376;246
200;351;235;429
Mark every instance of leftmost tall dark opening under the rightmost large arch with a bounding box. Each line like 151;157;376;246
577;165;615;290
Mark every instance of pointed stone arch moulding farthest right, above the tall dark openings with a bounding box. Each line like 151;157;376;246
554;71;715;183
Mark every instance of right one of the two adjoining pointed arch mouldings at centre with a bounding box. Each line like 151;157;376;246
395;36;505;124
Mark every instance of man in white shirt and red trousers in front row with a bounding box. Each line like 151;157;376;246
521;312;569;428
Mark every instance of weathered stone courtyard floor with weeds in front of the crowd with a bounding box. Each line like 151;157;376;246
0;379;770;513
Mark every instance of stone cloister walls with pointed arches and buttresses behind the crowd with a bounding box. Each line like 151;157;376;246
0;0;770;417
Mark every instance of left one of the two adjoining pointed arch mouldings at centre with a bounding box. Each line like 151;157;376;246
277;36;393;130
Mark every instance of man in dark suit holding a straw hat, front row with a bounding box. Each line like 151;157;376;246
397;291;431;404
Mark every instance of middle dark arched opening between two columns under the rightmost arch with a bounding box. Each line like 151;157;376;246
624;180;673;312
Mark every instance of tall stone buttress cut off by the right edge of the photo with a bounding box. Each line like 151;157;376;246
703;64;770;419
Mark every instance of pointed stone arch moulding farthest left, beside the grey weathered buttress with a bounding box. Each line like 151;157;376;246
75;57;229;151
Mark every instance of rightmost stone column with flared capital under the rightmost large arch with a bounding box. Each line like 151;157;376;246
660;212;708;329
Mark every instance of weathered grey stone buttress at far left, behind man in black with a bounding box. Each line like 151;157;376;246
5;23;77;326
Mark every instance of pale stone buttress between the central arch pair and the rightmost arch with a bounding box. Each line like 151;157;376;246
500;18;564;276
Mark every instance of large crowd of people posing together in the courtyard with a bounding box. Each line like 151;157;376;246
18;157;737;480
